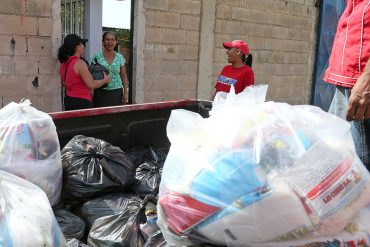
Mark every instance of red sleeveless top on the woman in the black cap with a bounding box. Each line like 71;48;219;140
59;56;92;101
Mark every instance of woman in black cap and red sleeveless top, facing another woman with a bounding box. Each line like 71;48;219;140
58;34;110;111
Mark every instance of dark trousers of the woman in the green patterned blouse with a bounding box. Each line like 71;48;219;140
93;88;123;107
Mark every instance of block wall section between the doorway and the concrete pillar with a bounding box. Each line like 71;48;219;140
139;0;201;102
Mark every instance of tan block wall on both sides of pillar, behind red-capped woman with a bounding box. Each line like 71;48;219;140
144;0;318;104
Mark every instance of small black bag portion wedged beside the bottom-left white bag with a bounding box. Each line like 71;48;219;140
54;209;85;240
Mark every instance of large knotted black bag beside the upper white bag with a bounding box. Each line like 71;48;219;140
62;135;135;204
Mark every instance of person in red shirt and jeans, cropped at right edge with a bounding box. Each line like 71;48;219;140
323;0;370;170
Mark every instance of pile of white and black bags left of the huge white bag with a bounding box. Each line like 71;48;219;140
0;100;166;247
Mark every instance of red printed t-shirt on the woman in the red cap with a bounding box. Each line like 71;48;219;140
215;65;254;94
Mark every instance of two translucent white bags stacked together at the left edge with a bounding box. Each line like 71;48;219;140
0;100;65;247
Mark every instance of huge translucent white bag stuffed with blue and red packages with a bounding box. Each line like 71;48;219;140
158;86;370;247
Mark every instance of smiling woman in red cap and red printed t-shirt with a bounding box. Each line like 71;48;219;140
215;40;254;95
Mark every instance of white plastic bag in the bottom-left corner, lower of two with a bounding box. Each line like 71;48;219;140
0;171;65;247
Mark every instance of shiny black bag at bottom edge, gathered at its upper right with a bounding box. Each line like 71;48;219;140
87;196;146;247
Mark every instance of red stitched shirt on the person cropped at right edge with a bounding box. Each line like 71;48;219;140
323;0;370;88
